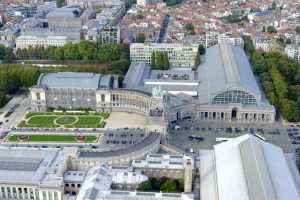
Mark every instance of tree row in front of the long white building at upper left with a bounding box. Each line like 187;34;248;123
16;40;129;63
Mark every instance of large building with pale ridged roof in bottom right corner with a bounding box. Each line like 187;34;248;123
199;135;300;200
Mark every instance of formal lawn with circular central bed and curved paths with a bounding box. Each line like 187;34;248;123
18;112;109;128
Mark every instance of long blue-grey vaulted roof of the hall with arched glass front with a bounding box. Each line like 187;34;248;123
198;42;261;102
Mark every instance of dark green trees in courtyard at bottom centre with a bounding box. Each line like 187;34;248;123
138;177;184;192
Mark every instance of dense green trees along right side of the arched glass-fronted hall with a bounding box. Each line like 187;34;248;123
244;38;300;121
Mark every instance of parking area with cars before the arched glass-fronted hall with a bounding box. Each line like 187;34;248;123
168;120;300;153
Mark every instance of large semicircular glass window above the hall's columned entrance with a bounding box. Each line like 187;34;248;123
212;90;257;105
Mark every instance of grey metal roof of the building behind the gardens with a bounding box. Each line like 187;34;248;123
38;72;111;89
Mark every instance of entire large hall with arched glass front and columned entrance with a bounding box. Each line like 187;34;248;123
196;42;276;122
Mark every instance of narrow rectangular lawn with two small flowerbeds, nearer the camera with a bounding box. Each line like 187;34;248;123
6;134;99;143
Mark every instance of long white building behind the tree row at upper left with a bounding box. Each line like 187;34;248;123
16;35;71;49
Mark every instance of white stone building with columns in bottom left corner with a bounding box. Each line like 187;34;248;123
0;147;74;200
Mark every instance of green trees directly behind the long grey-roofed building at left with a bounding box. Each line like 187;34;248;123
0;59;130;107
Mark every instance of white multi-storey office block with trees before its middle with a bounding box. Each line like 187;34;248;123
130;43;198;68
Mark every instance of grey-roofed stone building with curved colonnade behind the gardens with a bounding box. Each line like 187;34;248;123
30;72;163;116
